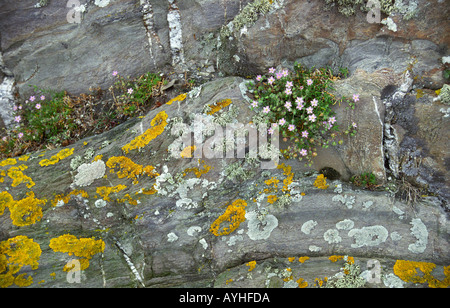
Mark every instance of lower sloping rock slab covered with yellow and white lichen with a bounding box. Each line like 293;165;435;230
0;77;450;287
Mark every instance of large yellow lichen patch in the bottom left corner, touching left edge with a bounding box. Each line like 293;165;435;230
0;235;42;288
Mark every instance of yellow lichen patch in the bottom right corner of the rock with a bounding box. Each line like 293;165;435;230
394;260;450;288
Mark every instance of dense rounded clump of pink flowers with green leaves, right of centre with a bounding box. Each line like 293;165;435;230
249;63;359;165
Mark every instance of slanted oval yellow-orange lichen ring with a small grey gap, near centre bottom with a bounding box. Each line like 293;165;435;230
209;199;247;236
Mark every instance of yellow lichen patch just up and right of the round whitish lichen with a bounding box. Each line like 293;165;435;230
106;156;159;184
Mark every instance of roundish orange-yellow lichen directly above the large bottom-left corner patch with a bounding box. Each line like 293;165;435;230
9;191;47;227
